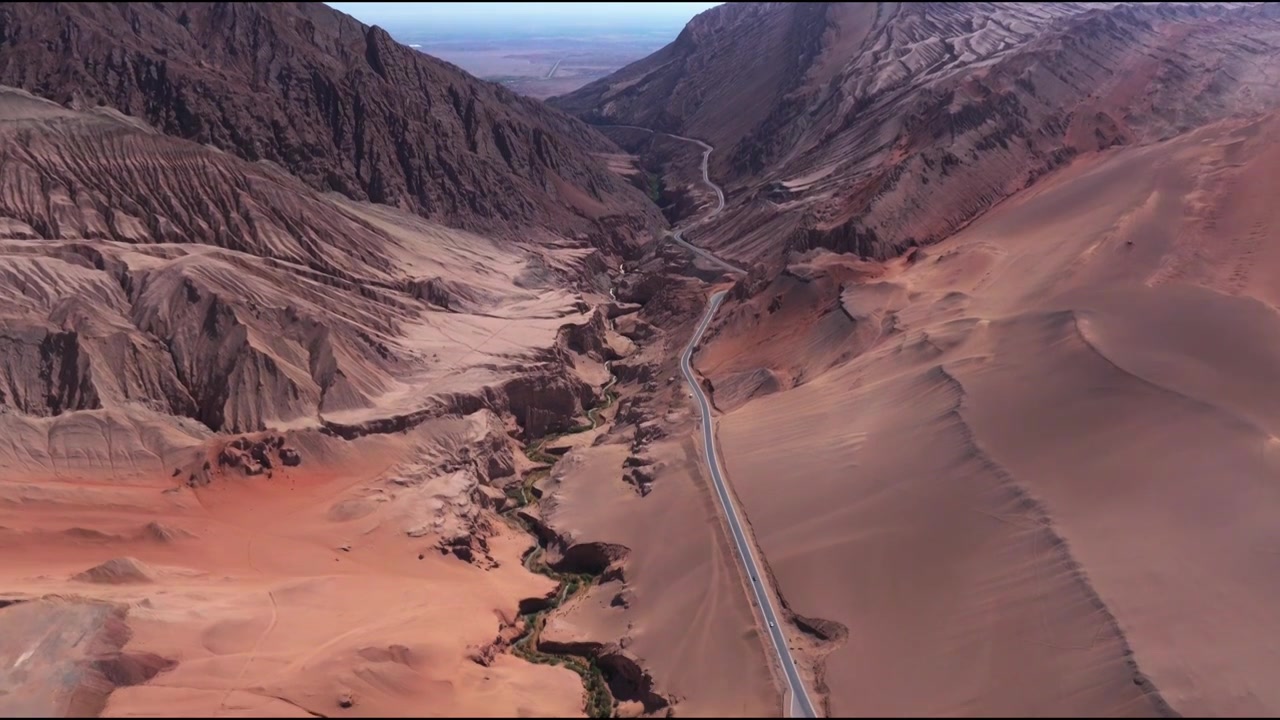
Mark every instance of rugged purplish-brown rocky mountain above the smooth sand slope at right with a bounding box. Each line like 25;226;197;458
552;3;1280;264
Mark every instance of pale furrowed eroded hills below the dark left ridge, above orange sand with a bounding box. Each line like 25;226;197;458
0;91;609;432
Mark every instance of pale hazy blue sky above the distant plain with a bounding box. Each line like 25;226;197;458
328;3;719;28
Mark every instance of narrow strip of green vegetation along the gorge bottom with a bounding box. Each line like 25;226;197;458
503;366;617;717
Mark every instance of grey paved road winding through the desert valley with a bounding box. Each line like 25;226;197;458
609;126;818;717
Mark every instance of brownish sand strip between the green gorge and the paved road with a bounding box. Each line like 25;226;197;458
532;430;781;717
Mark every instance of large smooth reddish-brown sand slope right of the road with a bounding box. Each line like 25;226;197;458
699;117;1280;715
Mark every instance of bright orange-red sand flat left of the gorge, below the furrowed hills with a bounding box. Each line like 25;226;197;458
0;412;582;716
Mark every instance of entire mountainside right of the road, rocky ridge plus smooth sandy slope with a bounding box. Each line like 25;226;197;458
556;3;1280;716
